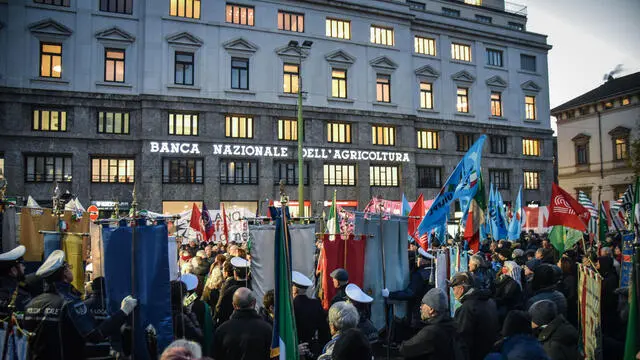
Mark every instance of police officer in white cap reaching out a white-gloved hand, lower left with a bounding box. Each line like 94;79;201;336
24;250;138;360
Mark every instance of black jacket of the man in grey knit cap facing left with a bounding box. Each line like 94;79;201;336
400;313;457;360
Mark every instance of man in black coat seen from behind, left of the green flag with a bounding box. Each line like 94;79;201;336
213;287;272;360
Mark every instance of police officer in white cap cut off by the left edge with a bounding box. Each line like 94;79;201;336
0;245;31;319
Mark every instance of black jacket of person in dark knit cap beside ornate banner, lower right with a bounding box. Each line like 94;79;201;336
538;315;579;360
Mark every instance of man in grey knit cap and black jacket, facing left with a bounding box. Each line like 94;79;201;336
400;288;465;360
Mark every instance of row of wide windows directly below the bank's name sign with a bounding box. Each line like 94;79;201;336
25;155;540;190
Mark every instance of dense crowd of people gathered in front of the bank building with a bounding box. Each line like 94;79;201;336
0;229;640;360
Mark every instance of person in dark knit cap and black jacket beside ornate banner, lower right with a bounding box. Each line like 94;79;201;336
529;300;580;360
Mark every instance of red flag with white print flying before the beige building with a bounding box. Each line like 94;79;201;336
547;183;591;231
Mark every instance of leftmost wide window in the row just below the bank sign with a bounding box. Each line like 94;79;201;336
25;154;72;182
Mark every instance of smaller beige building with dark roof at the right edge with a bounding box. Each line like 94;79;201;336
551;72;640;203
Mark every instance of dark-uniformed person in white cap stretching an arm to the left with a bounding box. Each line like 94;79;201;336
382;248;434;335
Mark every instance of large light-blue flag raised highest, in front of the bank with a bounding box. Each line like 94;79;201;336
418;135;487;236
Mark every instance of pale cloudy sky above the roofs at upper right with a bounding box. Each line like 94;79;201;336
520;0;640;131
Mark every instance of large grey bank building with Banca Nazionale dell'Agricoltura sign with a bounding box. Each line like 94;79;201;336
0;0;553;217
